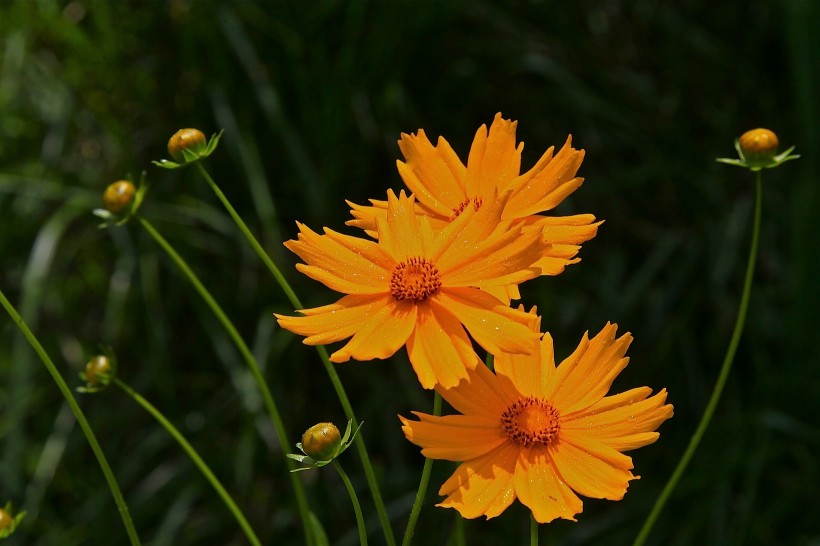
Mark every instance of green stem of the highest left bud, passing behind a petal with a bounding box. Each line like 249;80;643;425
195;162;396;546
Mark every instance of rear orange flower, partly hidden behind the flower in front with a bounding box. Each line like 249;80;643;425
347;113;600;298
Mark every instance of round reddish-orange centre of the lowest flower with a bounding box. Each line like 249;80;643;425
501;396;561;447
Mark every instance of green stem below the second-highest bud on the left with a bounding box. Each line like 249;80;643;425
135;215;312;544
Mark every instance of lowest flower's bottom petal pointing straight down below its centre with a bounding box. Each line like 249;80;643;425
515;449;583;523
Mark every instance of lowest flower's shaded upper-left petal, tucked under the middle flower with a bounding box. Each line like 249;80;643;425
436;356;510;420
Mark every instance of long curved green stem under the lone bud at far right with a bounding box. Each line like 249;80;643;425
633;171;763;546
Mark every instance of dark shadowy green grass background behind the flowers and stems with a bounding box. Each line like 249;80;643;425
0;0;820;546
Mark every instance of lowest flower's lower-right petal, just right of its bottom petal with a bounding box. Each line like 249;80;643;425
548;429;635;500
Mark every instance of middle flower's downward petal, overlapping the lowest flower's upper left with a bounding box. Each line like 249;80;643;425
407;300;479;389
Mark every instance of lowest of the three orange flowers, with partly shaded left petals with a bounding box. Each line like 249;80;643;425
400;324;672;523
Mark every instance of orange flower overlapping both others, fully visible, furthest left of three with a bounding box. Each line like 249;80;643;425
276;191;544;389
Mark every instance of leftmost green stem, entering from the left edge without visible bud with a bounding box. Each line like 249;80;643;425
0;290;140;546
